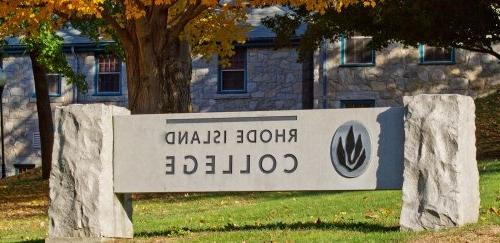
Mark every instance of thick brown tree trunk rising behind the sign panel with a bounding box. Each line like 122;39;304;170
104;6;196;114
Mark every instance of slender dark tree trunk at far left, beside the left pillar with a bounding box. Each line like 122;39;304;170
30;50;54;179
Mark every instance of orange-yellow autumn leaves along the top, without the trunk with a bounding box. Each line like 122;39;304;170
0;0;376;62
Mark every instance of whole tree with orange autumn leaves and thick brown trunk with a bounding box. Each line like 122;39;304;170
0;0;375;114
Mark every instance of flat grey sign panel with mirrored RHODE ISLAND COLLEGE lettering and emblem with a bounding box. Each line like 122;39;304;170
114;108;404;193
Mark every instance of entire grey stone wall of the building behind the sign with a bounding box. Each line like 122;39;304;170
2;43;500;176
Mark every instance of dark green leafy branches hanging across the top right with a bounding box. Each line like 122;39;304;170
265;0;500;59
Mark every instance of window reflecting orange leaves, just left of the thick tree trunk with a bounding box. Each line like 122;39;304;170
95;55;122;95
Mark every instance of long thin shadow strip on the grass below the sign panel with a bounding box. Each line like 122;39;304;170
135;222;399;237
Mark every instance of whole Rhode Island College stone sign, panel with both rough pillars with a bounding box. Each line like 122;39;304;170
48;95;480;242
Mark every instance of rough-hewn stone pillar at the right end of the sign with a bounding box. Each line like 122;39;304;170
400;95;480;231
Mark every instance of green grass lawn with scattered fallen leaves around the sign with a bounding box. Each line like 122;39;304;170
0;161;500;242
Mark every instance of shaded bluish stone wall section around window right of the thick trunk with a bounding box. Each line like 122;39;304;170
191;48;302;112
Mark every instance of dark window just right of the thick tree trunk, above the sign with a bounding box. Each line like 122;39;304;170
218;48;247;93
